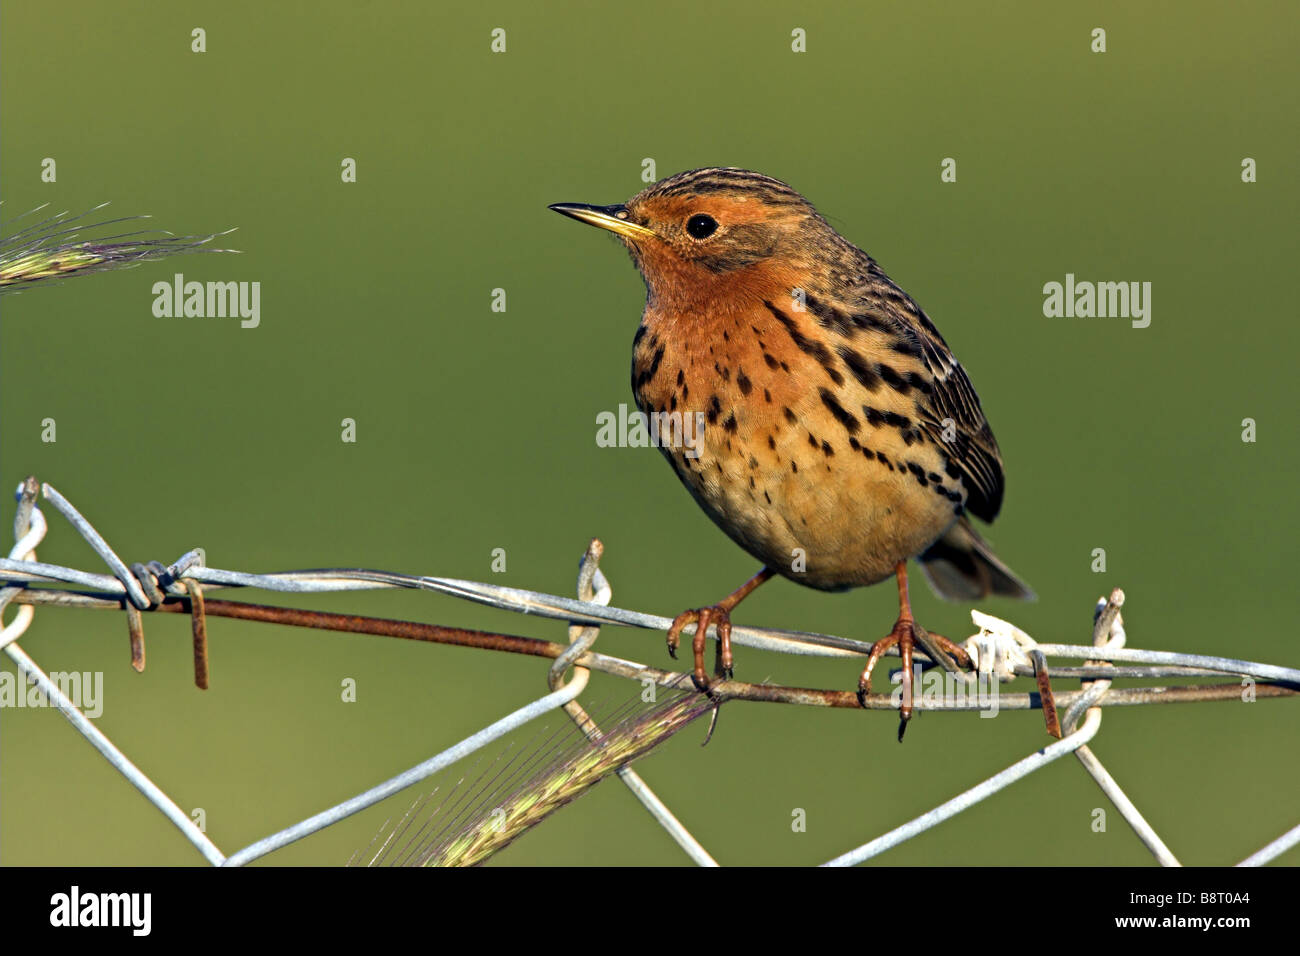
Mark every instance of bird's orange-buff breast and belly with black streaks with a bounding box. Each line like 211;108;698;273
632;300;963;589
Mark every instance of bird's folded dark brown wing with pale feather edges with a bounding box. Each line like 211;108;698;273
850;256;1004;522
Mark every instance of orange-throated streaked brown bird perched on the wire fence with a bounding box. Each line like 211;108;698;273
549;166;1034;740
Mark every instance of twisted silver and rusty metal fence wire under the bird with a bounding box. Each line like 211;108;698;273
0;479;1300;866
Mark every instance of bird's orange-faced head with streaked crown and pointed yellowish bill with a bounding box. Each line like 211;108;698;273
550;168;842;303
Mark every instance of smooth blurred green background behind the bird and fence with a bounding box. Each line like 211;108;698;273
0;0;1300;865
